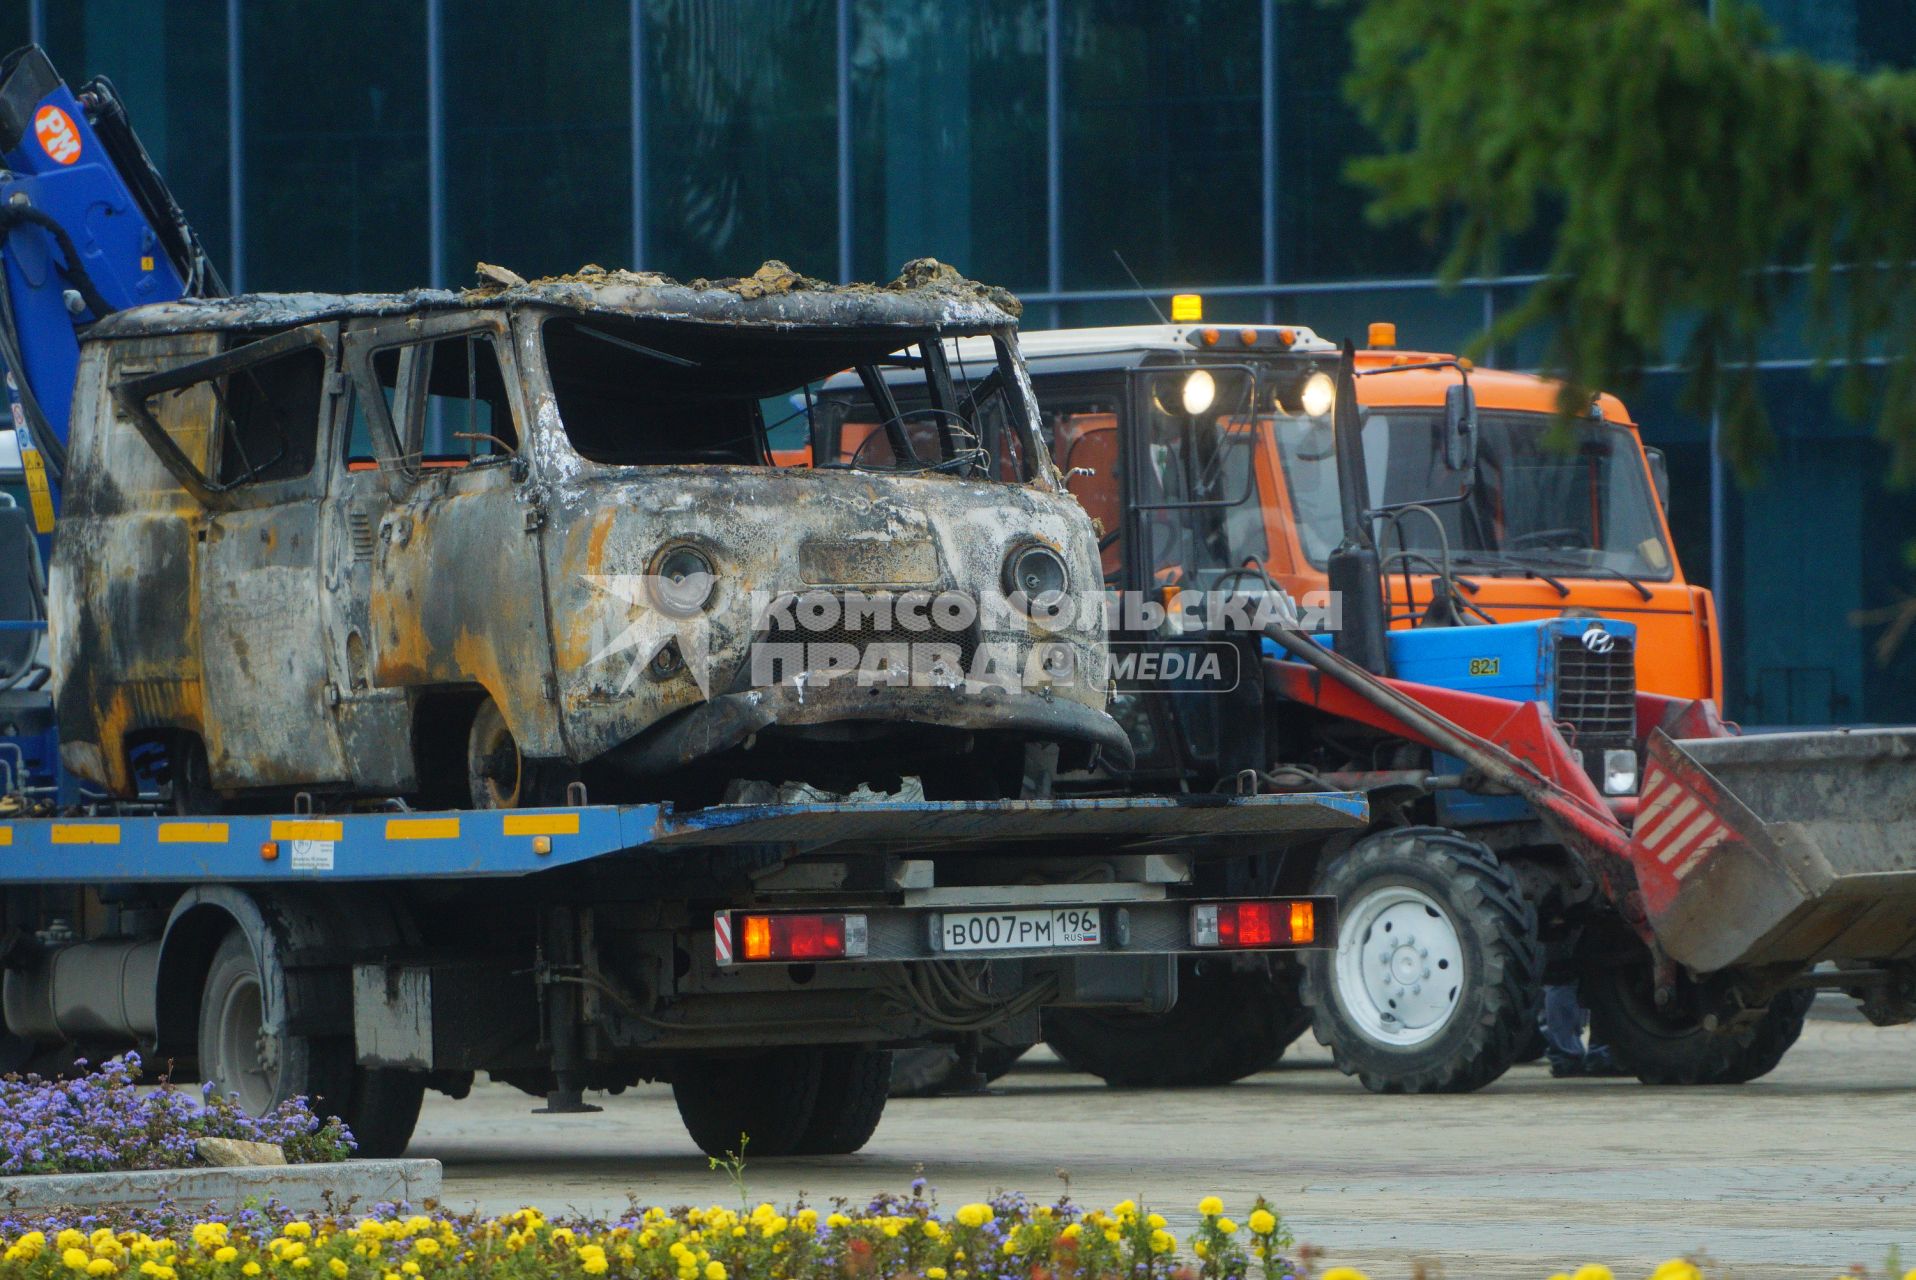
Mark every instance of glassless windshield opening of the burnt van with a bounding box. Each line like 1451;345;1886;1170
542;316;1031;479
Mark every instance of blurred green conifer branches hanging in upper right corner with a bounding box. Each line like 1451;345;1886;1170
1349;0;1916;483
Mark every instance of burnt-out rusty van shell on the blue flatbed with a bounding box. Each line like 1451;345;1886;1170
50;264;1129;803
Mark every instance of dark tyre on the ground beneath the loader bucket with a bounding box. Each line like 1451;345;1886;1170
1583;966;1816;1085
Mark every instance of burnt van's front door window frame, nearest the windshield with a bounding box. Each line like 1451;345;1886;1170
333;310;531;485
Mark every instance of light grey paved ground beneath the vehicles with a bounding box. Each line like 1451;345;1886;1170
419;1002;1916;1280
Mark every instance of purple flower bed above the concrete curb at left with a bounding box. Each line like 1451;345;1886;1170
0;1054;354;1175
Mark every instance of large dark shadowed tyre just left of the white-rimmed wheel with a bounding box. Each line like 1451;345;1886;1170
1044;960;1311;1088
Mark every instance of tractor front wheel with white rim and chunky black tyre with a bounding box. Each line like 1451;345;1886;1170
1303;826;1544;1094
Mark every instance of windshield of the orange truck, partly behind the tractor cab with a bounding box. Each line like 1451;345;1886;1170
1268;408;1673;581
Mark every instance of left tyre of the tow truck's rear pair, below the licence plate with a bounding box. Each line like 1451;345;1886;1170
673;1048;823;1159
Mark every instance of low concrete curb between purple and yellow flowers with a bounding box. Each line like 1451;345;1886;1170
0;1159;439;1213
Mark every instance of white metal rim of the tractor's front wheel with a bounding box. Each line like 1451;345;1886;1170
1335;883;1464;1048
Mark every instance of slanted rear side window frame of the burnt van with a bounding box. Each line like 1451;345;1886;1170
111;322;343;512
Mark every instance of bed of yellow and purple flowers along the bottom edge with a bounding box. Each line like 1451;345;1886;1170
0;1182;1885;1280
